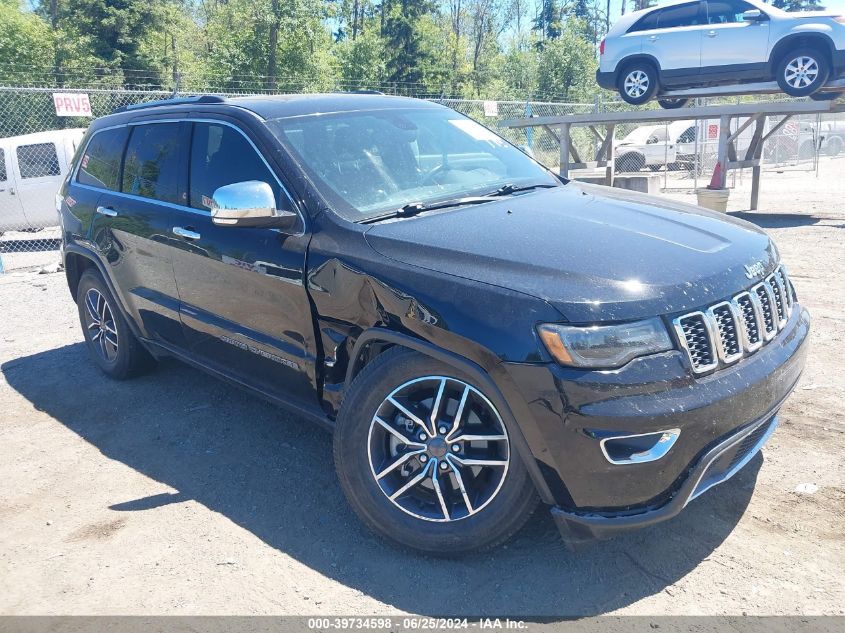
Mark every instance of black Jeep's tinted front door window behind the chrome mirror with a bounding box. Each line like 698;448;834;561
190;123;279;210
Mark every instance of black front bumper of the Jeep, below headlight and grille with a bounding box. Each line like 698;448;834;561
498;303;809;542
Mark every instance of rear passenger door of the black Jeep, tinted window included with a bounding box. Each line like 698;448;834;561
84;121;187;347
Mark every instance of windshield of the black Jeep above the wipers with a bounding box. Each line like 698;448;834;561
268;108;560;221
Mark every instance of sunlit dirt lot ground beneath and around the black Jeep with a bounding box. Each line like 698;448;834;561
0;205;845;616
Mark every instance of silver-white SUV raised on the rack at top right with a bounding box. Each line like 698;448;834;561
596;0;845;108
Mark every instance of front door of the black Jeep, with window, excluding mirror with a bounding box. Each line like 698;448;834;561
171;121;316;404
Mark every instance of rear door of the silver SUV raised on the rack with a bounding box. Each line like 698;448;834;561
641;2;707;84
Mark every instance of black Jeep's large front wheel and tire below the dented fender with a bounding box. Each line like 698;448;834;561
334;348;538;556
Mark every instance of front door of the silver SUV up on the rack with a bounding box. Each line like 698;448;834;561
701;0;769;80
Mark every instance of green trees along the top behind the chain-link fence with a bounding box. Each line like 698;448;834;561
0;0;608;99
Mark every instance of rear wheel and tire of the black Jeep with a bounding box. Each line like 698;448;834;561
76;268;155;380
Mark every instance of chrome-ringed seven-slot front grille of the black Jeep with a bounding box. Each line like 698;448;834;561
673;266;795;374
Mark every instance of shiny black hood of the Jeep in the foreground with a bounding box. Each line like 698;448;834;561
366;183;778;323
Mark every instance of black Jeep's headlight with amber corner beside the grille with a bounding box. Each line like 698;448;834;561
538;318;674;369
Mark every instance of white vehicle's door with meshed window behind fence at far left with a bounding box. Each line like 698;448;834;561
13;141;62;228
